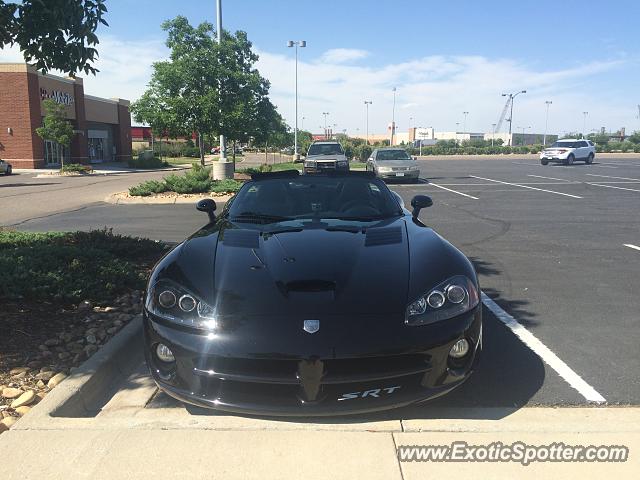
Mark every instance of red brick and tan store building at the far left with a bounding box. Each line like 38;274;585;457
0;63;131;168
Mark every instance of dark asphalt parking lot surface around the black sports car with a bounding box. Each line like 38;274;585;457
10;158;640;410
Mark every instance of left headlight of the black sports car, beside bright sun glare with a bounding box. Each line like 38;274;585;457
145;279;216;331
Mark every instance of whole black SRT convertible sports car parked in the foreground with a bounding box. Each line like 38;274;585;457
144;171;482;415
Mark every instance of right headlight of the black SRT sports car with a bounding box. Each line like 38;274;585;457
405;275;480;325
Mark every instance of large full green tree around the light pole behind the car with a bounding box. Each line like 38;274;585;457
133;16;275;168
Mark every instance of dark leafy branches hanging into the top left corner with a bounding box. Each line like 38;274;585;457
0;0;108;75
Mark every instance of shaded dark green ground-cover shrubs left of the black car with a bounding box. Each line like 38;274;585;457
0;229;166;305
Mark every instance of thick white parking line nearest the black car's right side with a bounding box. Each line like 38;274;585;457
482;292;607;403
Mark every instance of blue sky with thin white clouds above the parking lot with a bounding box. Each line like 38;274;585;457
0;0;640;134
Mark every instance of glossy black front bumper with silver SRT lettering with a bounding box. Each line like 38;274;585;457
144;306;482;416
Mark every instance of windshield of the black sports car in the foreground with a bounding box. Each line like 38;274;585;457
229;175;402;223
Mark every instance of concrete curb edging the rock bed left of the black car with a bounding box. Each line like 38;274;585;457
12;315;142;430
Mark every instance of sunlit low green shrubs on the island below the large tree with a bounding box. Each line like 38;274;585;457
129;163;242;197
